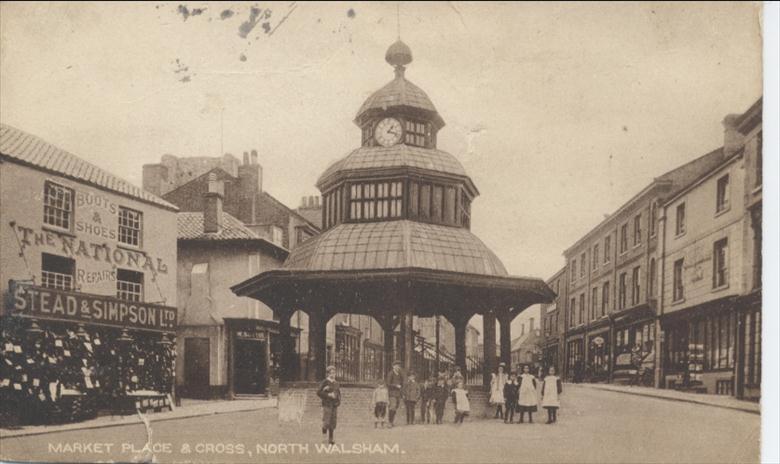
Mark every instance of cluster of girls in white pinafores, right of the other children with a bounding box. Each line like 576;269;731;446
490;363;563;424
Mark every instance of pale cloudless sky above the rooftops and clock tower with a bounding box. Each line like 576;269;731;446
0;2;761;334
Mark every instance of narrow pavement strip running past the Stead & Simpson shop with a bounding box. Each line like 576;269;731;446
0;398;276;439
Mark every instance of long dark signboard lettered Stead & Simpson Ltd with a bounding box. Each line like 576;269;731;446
10;283;177;332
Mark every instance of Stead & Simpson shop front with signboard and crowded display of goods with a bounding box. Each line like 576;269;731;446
0;282;177;424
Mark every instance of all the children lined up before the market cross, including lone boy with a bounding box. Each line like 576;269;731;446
317;362;563;444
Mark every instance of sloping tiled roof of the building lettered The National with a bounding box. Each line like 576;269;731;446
0;124;178;211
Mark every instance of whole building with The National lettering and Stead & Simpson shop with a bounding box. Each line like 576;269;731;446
0;124;177;424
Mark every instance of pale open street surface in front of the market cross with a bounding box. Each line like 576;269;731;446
0;385;761;464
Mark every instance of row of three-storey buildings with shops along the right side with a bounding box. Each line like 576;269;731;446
556;99;762;399
